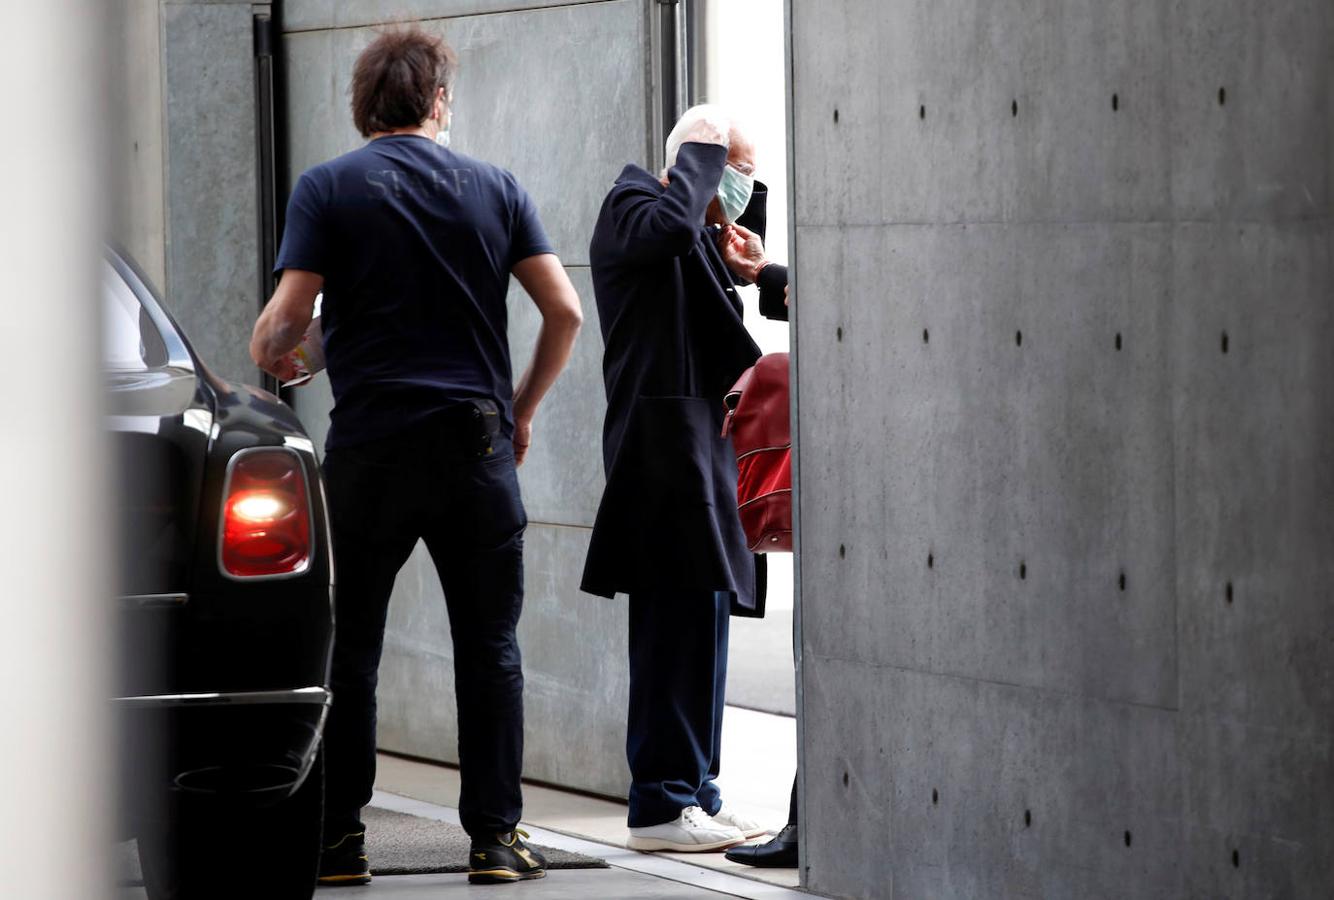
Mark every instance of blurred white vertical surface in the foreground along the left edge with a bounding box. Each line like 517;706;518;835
0;0;111;900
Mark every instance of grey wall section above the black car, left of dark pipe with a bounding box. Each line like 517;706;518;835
108;0;268;384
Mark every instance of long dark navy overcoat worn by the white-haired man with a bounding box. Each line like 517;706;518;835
582;143;764;615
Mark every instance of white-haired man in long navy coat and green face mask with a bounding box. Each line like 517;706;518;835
583;107;782;851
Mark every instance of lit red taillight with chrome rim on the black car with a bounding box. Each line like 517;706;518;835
221;448;311;579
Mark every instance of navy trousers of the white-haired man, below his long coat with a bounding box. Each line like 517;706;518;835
626;591;731;828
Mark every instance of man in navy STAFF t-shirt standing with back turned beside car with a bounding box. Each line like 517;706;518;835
251;29;582;884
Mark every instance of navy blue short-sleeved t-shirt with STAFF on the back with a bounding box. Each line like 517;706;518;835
273;135;555;448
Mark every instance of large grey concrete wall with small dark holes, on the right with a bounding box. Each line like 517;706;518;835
790;0;1334;897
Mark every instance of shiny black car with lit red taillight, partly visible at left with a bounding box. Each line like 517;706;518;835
101;251;334;900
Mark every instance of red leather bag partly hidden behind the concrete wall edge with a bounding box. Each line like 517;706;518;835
723;353;792;553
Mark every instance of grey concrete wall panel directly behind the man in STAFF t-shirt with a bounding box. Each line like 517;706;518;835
284;0;650;796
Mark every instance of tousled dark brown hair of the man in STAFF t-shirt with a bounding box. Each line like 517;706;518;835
352;27;459;137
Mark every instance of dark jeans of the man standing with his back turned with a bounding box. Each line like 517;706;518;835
324;409;527;840
